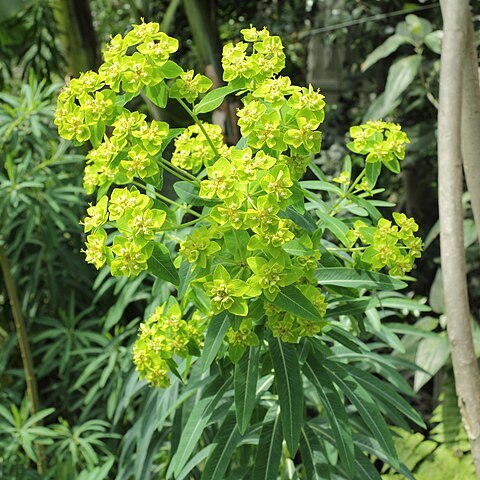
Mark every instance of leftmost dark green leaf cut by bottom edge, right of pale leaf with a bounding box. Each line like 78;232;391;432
201;411;242;480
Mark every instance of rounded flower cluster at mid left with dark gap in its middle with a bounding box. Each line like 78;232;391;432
83;188;166;276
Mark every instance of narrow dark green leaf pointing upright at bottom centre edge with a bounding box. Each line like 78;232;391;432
252;405;283;480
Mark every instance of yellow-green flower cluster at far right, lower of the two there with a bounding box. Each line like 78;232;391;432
349;212;423;276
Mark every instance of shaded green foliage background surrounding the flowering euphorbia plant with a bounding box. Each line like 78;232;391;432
0;0;480;480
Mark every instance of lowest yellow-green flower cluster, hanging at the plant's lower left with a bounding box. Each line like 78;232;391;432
133;298;205;388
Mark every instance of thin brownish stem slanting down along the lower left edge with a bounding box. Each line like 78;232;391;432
0;240;45;474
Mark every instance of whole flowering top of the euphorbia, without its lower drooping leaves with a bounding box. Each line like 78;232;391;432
55;23;422;387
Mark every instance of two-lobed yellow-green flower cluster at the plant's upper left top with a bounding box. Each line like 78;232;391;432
55;23;178;146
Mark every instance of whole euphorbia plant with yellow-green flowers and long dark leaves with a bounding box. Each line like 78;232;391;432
56;23;422;479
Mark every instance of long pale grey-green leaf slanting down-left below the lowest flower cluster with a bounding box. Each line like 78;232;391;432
171;379;231;477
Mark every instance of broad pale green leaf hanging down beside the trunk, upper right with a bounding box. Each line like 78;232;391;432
383;55;422;113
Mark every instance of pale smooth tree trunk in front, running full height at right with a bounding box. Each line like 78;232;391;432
438;0;480;479
